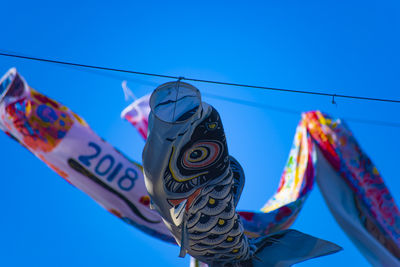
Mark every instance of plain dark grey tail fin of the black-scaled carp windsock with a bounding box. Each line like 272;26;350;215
248;229;342;267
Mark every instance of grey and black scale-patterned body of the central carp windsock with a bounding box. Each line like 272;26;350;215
187;171;253;262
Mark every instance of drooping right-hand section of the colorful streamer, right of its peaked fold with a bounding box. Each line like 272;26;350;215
302;111;400;266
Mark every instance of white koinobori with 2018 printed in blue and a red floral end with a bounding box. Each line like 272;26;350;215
0;69;174;242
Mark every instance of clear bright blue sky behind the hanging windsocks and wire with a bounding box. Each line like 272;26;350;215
0;0;400;267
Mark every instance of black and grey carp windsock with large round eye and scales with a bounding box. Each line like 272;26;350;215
143;81;341;266
